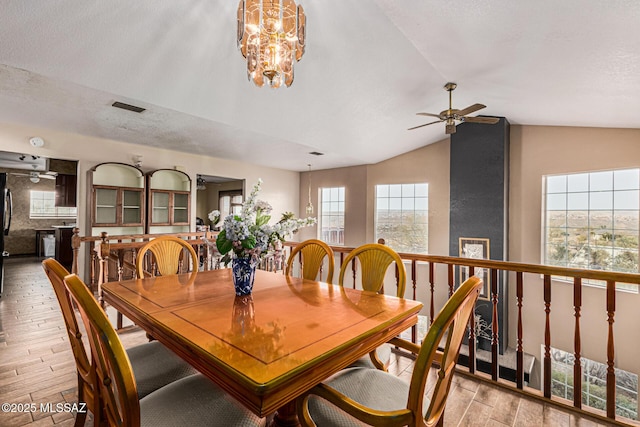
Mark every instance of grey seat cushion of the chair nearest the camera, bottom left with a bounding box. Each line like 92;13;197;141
140;374;266;427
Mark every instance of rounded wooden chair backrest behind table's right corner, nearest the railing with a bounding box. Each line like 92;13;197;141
338;243;407;298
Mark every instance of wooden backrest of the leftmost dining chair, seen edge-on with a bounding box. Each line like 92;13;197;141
42;258;97;414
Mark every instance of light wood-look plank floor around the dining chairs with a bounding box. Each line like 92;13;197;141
0;258;620;427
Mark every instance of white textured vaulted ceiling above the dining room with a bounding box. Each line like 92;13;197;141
0;0;640;171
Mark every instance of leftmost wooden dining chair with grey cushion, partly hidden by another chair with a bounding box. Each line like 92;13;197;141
42;258;197;426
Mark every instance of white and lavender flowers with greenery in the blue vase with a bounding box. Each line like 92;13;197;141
209;179;316;264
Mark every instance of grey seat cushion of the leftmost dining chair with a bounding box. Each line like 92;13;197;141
127;341;197;398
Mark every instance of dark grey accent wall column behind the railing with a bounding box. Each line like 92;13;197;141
449;118;509;354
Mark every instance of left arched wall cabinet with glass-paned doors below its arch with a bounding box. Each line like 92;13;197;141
89;163;145;232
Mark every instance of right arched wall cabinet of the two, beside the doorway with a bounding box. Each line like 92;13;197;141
147;169;191;233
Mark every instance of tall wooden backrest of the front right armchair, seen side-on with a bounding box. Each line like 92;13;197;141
407;276;482;426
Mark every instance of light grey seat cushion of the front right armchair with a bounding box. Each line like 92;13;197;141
309;367;428;427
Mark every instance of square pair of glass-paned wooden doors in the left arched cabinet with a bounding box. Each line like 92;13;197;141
92;185;144;227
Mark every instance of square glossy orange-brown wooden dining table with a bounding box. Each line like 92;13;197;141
102;269;422;426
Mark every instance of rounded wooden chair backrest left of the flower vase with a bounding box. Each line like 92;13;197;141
136;236;199;278
